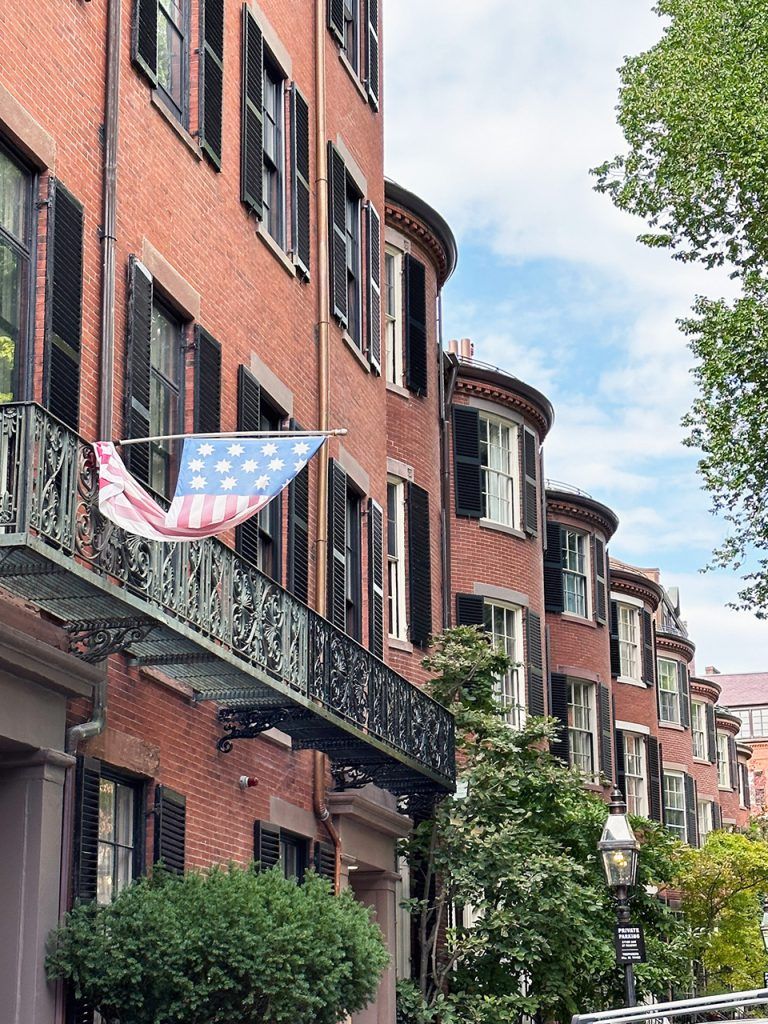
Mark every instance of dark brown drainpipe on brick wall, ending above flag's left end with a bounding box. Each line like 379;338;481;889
98;0;122;440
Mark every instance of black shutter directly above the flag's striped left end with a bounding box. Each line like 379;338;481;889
125;256;153;483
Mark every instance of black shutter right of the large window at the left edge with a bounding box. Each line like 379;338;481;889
43;181;83;430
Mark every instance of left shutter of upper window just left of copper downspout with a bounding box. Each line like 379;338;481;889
240;4;264;217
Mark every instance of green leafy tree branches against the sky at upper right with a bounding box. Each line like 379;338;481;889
594;0;768;617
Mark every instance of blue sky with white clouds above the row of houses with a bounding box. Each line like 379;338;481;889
384;0;768;672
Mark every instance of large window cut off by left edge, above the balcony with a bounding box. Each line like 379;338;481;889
0;146;33;401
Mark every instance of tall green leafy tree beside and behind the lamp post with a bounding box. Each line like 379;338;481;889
401;627;689;1024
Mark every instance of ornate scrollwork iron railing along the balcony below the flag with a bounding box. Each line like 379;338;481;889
0;403;455;787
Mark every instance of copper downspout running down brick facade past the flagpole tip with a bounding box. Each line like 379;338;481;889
312;0;341;894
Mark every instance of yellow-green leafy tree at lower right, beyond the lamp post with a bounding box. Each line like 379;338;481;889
677;831;768;992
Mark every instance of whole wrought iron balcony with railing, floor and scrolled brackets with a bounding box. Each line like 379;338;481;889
0;403;455;795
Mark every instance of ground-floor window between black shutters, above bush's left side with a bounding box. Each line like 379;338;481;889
96;773;139;903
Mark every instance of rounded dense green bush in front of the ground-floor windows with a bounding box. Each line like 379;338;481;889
47;865;388;1024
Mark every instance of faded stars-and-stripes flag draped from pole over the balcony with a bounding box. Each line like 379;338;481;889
93;433;326;541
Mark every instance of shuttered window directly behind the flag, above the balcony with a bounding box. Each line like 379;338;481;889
150;299;184;496
